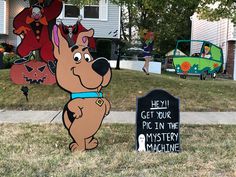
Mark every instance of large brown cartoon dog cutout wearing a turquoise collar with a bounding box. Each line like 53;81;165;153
53;26;111;152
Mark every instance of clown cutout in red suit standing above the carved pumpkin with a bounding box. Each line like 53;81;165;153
13;0;62;74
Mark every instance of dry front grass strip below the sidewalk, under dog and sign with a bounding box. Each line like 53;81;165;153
0;124;236;177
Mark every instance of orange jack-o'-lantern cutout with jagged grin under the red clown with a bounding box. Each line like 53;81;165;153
10;60;56;85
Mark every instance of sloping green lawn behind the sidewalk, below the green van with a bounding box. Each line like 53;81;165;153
0;70;236;111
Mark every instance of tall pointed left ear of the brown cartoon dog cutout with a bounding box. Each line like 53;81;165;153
52;25;68;60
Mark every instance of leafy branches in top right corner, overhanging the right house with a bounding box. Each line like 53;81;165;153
197;0;236;23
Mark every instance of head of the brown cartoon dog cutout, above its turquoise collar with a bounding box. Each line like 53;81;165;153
53;26;111;93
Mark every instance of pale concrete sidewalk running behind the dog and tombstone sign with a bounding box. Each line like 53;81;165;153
0;110;236;125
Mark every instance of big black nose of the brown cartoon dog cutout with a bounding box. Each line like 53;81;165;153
92;58;110;76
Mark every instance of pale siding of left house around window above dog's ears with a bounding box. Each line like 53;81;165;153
57;1;120;39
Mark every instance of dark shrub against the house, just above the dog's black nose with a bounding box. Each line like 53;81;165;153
97;39;112;60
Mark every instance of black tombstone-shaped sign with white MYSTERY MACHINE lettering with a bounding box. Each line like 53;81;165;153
136;90;180;152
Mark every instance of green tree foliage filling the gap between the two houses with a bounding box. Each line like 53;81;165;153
111;0;200;54
